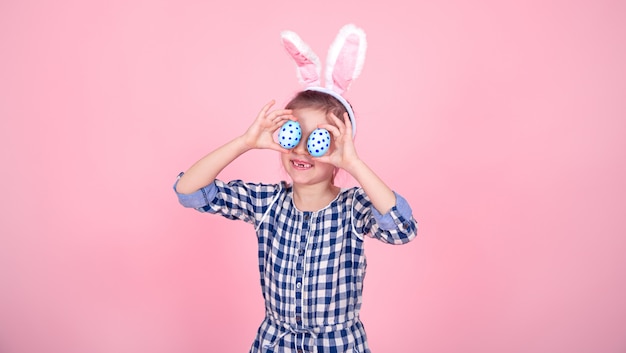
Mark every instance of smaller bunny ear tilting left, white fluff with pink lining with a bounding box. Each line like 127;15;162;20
280;31;322;87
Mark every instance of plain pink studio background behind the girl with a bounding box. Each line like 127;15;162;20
0;0;626;353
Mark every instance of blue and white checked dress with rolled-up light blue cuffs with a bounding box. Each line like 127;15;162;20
174;173;417;353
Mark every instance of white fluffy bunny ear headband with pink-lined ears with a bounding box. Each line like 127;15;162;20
281;24;367;136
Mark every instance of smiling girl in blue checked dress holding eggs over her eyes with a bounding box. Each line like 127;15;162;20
174;25;417;353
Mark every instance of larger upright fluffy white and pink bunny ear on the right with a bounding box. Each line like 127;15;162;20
326;24;367;94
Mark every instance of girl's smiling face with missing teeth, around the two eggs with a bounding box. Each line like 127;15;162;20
281;108;335;185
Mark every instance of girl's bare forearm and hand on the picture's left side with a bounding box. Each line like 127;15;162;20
176;100;294;194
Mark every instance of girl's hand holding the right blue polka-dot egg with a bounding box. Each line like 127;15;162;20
316;113;359;172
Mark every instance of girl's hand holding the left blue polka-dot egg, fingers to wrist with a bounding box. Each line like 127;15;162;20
243;100;296;152
